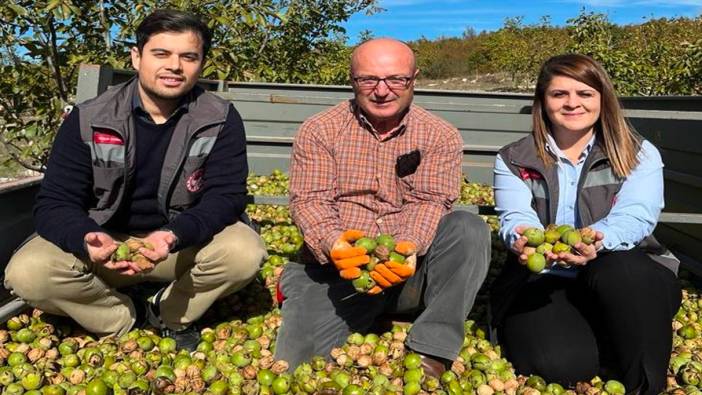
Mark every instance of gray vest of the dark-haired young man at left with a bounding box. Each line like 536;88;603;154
78;78;229;225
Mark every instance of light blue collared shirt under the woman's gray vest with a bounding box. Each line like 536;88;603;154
494;135;664;260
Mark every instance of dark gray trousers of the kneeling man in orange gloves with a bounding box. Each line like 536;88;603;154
275;211;490;369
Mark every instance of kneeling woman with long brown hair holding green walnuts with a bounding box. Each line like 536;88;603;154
490;54;681;394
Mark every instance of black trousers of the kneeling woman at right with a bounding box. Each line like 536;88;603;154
492;249;682;394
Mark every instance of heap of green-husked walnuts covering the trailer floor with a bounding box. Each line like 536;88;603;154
13;176;702;395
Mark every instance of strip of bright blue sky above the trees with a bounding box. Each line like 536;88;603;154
344;0;702;44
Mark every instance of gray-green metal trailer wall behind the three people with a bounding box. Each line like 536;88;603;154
77;66;702;273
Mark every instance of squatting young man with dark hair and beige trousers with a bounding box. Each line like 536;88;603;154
5;10;266;349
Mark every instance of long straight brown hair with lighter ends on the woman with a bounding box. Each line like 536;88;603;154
532;54;641;177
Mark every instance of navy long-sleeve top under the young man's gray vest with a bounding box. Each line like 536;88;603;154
34;106;248;255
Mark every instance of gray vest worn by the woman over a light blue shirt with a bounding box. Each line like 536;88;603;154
499;135;679;273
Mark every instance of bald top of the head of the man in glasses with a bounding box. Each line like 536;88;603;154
351;38;417;75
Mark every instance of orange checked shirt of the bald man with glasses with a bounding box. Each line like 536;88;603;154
290;100;463;263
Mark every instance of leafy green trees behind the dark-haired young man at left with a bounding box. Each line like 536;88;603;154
0;0;378;171
